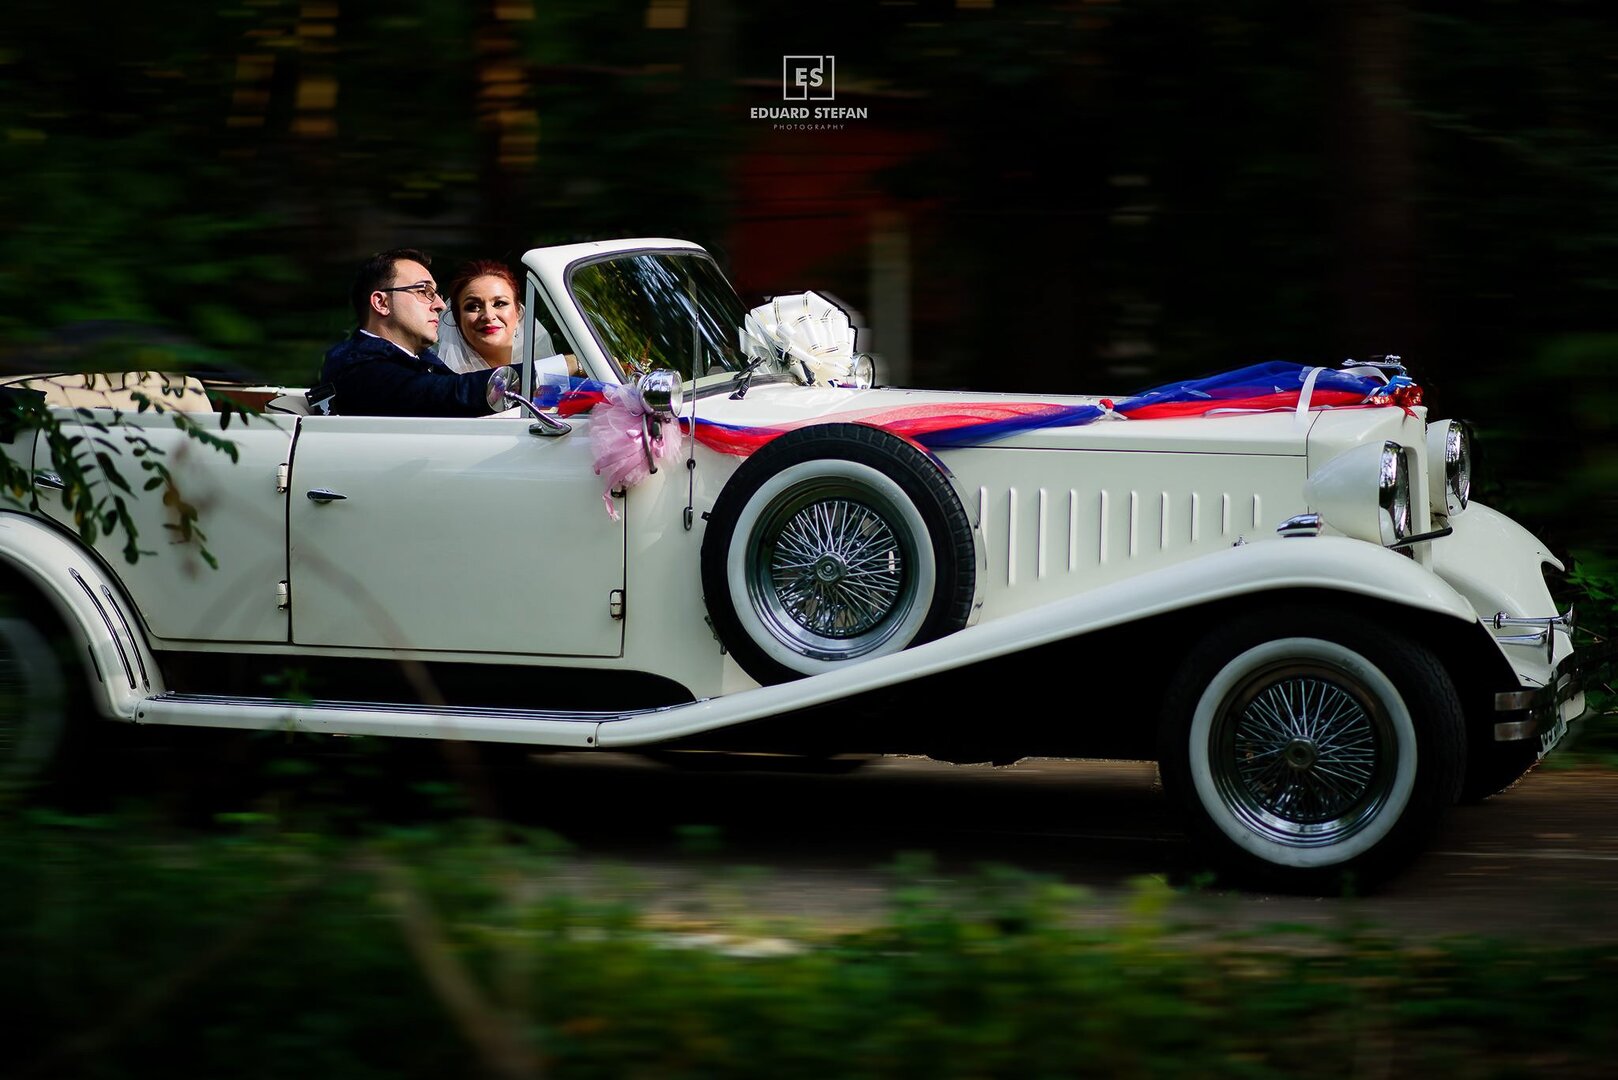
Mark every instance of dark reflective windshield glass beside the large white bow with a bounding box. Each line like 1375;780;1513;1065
568;251;785;390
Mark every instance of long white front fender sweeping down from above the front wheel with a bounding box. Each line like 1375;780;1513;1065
597;536;1477;748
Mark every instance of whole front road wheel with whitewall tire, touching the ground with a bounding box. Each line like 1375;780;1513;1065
1160;609;1466;892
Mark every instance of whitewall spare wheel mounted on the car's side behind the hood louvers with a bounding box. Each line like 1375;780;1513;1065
702;424;977;685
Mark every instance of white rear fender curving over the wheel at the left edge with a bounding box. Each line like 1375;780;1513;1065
0;512;163;719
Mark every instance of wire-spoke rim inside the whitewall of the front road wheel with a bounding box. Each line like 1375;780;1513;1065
1210;664;1395;845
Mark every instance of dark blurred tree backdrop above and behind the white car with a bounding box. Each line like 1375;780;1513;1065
0;0;1618;551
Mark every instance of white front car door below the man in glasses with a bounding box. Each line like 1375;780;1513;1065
288;415;628;656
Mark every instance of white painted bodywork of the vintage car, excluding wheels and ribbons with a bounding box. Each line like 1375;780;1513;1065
0;240;1582;873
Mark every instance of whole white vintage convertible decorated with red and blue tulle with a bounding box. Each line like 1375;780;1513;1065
0;240;1584;889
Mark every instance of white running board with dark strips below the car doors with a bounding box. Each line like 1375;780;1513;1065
134;693;676;750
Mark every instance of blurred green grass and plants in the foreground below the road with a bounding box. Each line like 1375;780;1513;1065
0;816;1618;1078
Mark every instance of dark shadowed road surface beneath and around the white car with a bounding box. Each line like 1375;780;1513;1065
94;745;1618;946
